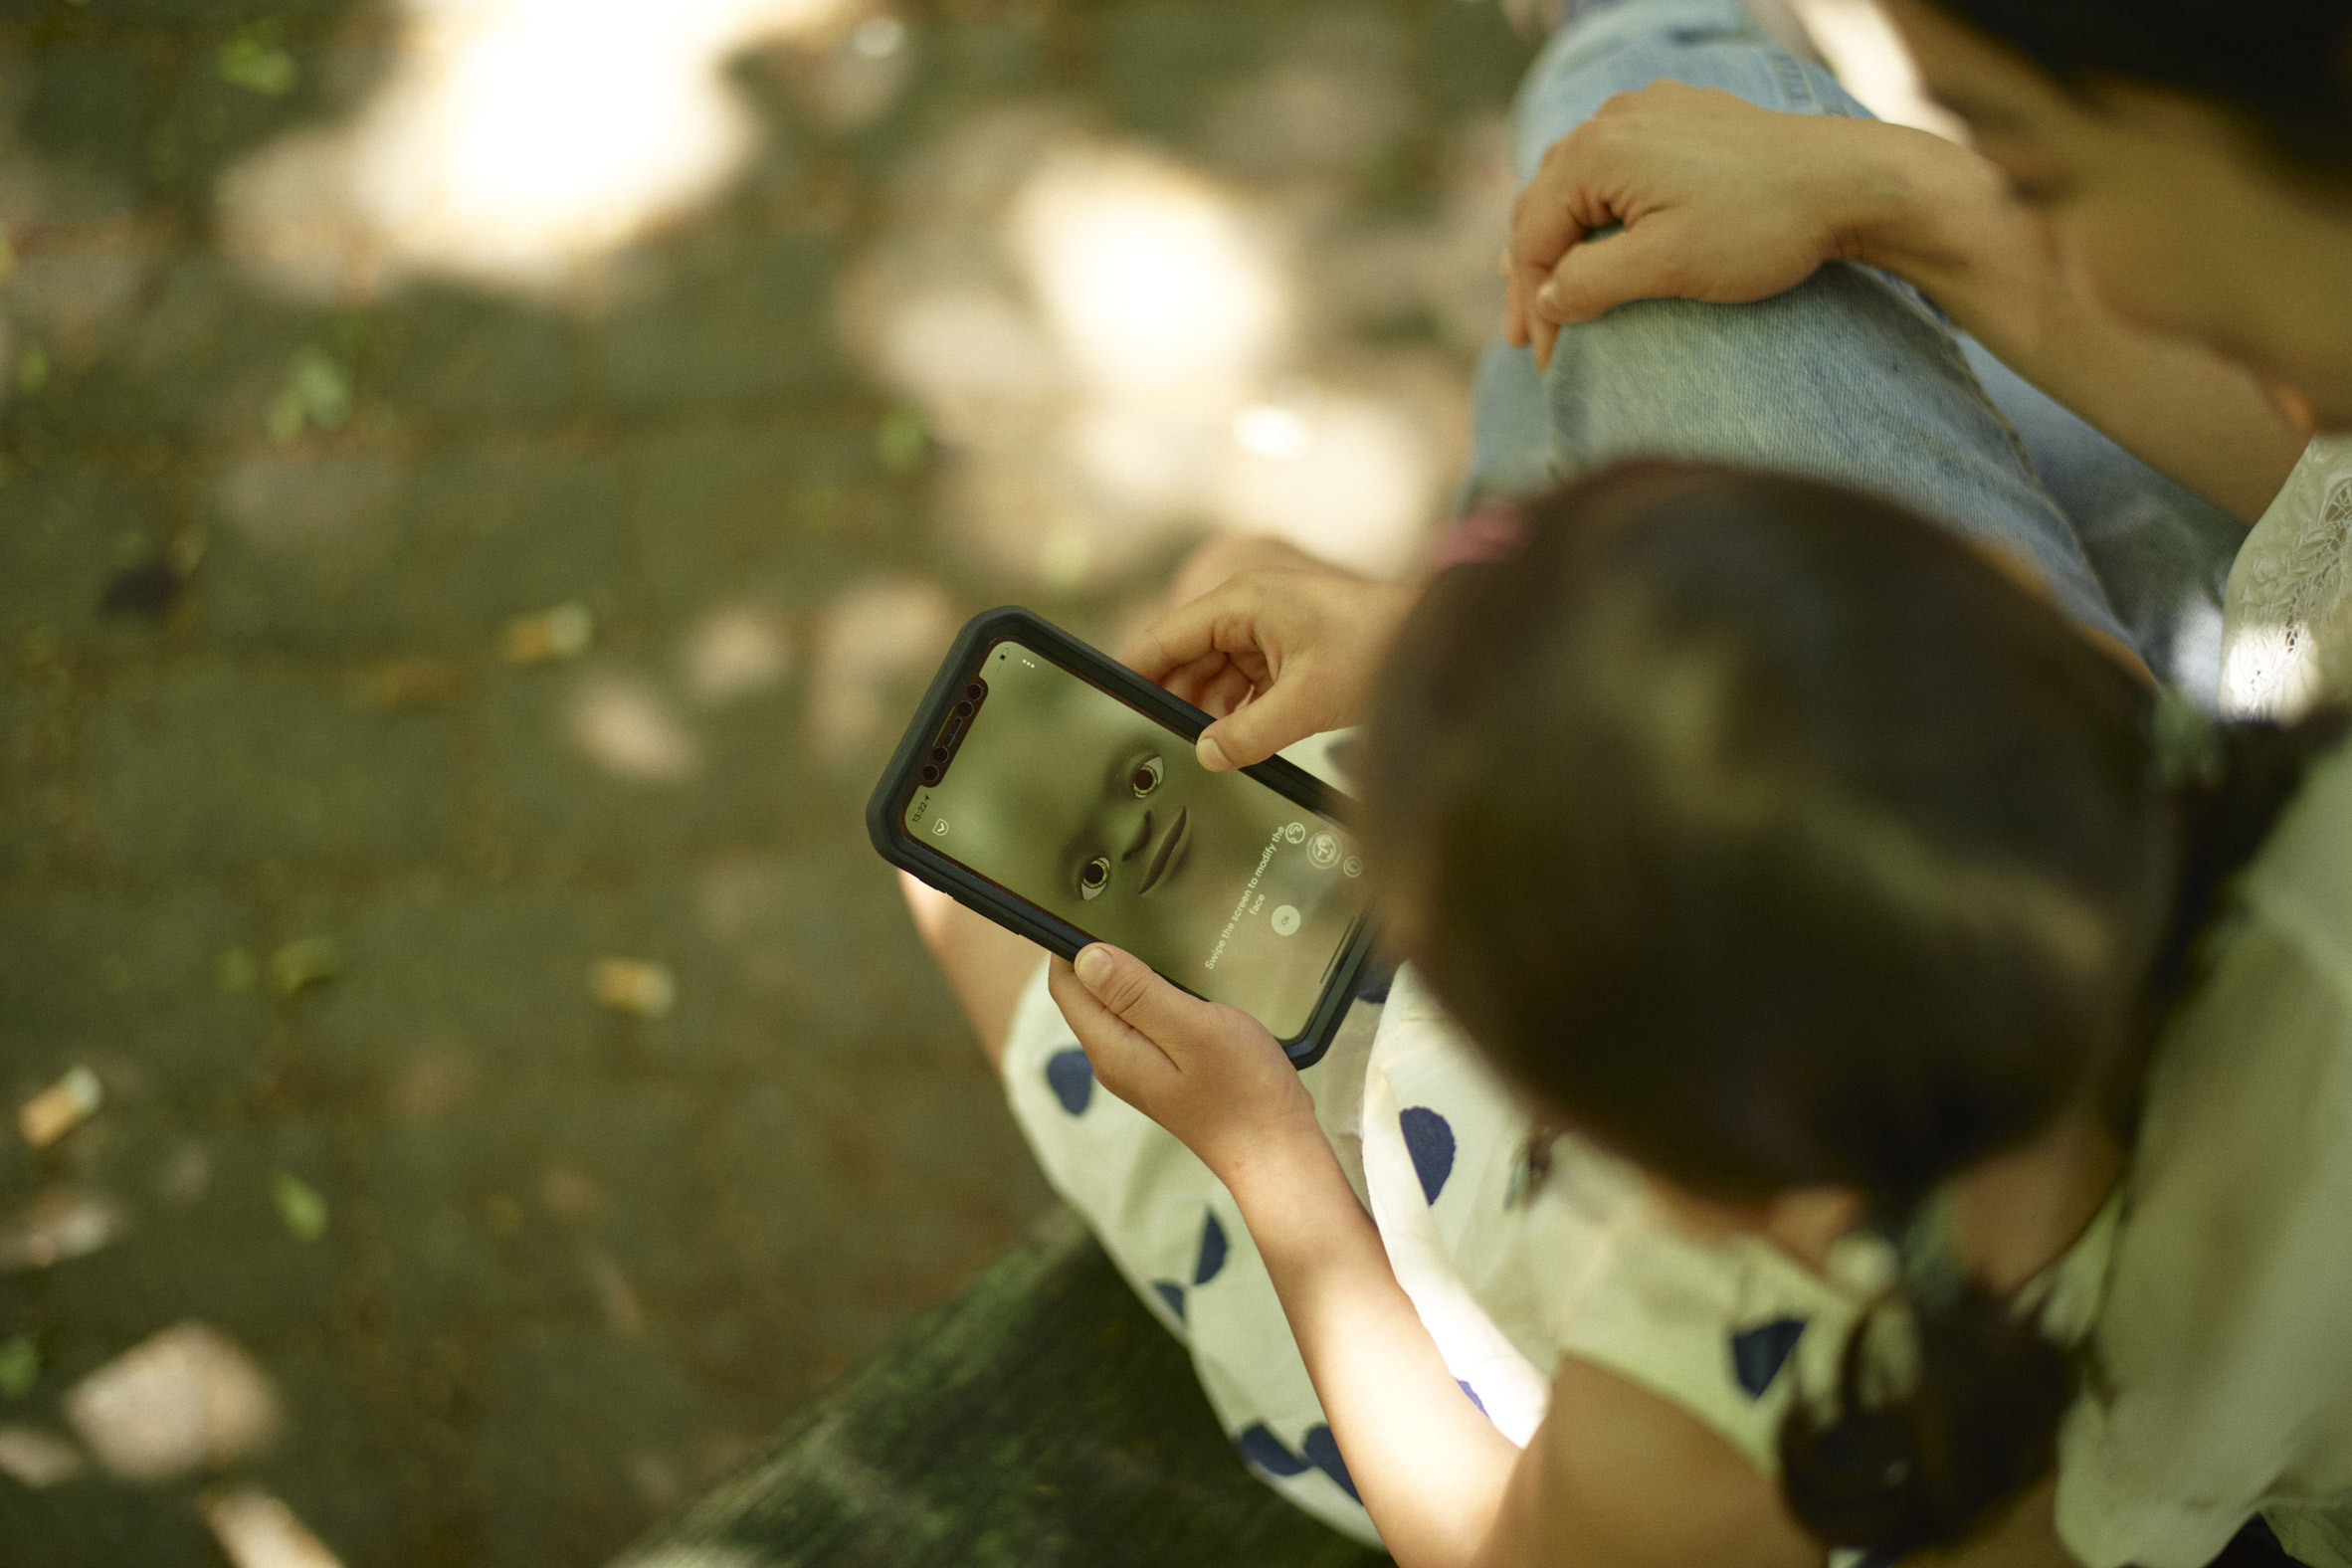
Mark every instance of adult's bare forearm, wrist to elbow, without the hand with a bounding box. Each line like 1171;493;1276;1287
1828;120;2305;522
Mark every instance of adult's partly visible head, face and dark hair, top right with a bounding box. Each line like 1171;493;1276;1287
1893;0;2352;428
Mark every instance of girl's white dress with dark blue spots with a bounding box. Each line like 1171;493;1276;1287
1004;949;2119;1544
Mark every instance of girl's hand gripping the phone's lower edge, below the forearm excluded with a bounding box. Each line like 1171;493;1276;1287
1047;942;1322;1187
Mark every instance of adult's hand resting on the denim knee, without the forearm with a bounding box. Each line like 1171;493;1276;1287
1503;83;1886;364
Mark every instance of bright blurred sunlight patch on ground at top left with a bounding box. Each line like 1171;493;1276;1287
221;0;865;298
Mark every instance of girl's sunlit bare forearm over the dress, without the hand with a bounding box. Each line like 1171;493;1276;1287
1226;1140;1519;1568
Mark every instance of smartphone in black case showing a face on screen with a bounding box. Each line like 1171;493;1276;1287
866;609;1369;1068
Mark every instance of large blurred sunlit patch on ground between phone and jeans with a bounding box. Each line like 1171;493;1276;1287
849;103;1507;590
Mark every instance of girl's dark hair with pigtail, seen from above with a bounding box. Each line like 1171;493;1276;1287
1359;463;2343;1554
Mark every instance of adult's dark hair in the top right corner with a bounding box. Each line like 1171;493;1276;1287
1931;0;2352;183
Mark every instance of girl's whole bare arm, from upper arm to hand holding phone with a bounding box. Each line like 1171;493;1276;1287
1052;945;1823;1568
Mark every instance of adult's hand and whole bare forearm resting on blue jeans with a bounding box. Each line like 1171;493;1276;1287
1503;83;2309;522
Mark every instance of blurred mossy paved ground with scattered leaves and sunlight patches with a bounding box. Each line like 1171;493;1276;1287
0;0;1526;1568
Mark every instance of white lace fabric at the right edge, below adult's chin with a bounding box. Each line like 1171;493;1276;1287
2221;435;2352;719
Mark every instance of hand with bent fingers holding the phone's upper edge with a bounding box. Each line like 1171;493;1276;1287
1126;571;1414;771
